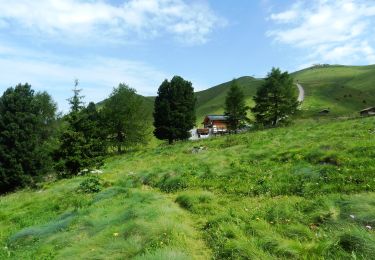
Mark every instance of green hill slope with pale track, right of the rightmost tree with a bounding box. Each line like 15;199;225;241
293;65;375;117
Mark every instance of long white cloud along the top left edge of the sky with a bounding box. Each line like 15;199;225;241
0;0;225;44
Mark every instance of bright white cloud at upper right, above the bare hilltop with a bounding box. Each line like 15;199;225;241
267;0;375;64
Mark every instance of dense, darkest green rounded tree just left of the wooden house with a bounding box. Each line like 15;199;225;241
154;76;196;144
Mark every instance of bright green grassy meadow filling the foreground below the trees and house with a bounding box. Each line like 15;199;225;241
0;117;375;259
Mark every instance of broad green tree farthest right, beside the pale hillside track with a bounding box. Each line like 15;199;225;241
251;68;299;126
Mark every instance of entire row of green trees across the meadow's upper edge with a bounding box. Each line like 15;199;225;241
0;69;298;194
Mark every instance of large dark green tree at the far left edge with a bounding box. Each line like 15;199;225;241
0;83;56;193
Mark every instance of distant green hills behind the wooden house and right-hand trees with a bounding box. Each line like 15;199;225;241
196;65;375;123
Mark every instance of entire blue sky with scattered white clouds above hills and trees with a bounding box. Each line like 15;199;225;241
0;0;375;111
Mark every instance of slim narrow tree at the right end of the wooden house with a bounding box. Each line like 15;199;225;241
225;80;249;131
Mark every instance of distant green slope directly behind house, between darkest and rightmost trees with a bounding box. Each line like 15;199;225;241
196;76;263;126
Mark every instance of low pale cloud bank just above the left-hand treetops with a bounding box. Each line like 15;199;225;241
0;46;170;111
